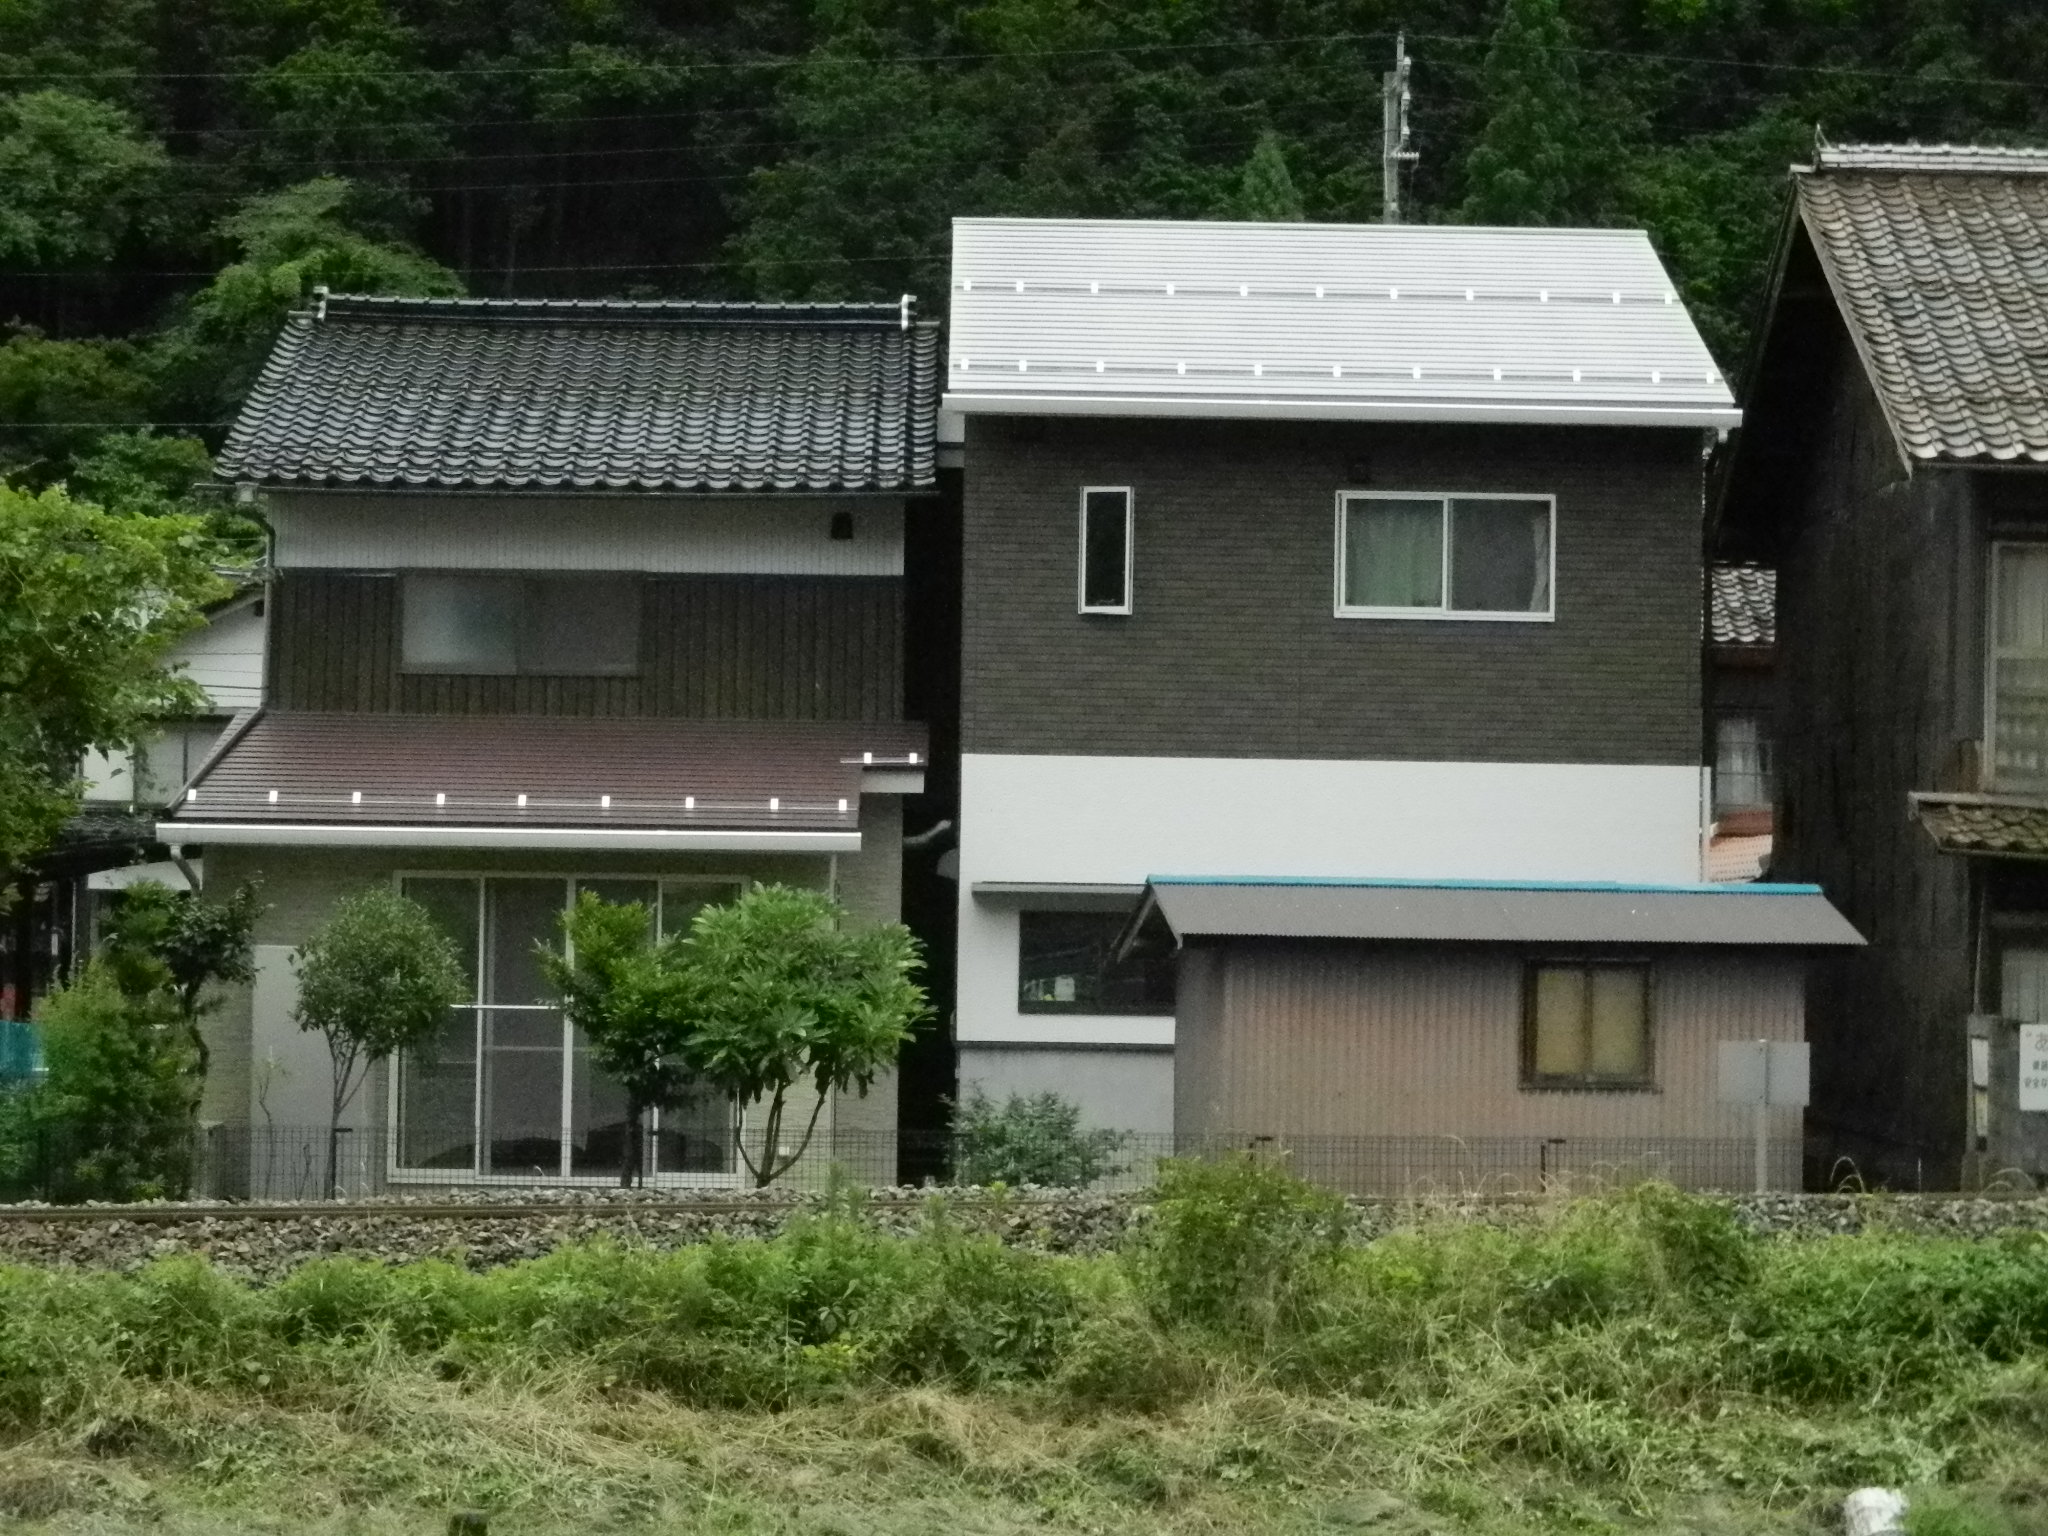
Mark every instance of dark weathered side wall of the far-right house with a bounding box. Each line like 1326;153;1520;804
1772;326;1982;1188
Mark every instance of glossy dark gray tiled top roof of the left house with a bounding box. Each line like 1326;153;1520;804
219;295;938;492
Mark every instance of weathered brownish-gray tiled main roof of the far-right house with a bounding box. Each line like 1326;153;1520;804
1794;145;2048;461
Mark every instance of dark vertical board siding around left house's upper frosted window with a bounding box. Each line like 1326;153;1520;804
268;569;903;721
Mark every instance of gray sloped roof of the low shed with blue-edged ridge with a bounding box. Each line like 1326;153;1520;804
1147;877;1864;948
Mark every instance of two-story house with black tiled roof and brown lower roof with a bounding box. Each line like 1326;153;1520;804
158;295;938;1184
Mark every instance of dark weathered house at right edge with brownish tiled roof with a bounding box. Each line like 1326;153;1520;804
1716;145;2048;1188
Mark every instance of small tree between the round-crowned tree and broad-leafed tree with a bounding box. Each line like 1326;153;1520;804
541;891;702;1186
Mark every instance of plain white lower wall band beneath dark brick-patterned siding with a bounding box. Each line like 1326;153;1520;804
958;754;1702;1049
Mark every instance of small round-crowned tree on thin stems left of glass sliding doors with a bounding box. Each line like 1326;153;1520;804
293;889;469;1190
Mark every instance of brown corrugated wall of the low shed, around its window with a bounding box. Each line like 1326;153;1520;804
1174;942;1802;1141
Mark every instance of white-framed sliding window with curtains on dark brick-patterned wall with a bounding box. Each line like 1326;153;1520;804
1335;492;1556;623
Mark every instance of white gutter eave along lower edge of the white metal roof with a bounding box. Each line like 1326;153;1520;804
940;393;1743;430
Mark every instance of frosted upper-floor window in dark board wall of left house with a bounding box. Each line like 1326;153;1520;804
401;573;639;678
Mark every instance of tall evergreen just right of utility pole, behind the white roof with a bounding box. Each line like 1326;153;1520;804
1458;0;1587;223
